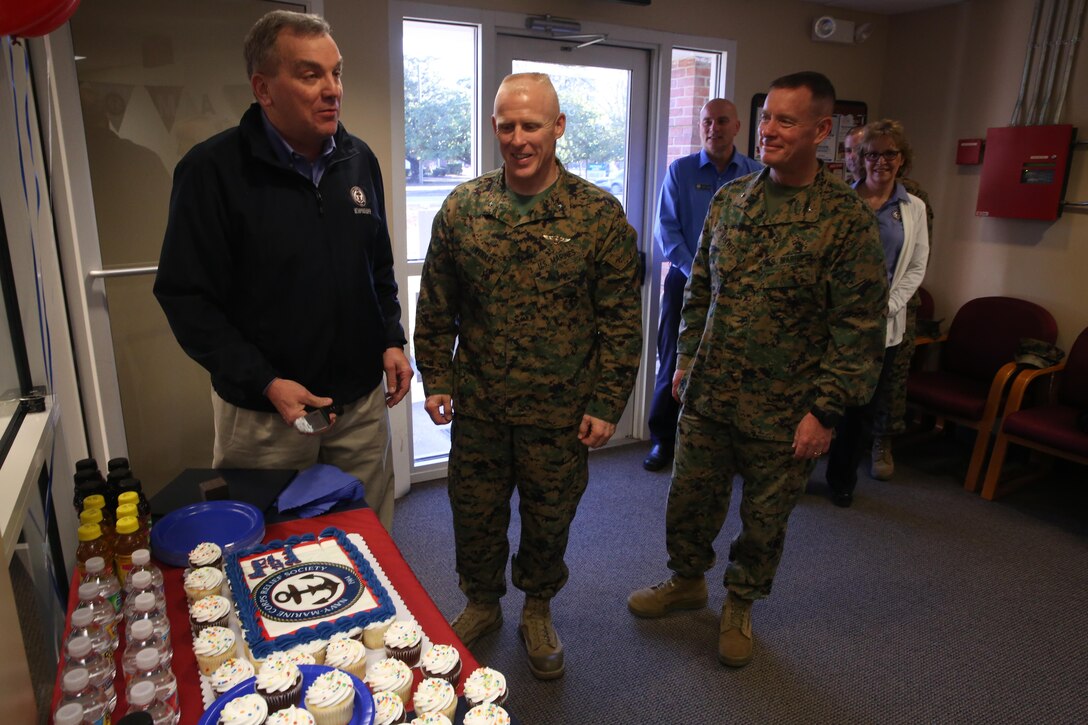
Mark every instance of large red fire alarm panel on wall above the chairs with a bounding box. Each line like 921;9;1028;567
975;124;1076;221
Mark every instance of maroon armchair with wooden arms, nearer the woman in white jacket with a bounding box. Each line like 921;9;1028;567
906;297;1058;491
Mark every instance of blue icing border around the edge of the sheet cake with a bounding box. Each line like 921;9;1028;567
225;526;396;658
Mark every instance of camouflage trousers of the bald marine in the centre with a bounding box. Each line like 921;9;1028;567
448;415;589;602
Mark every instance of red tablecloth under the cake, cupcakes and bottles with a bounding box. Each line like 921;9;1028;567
50;508;479;725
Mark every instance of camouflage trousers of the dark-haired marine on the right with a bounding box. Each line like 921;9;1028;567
665;406;816;599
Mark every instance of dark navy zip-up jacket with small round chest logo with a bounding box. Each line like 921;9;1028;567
154;103;406;411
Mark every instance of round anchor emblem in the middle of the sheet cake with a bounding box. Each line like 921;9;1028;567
254;562;369;623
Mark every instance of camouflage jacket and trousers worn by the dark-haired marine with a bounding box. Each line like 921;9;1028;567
666;161;887;599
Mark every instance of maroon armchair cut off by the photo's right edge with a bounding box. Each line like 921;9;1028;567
982;328;1088;501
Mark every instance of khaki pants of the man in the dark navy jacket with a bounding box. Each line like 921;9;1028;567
211;384;394;531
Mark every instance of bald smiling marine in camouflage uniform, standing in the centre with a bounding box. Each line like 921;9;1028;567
415;74;642;679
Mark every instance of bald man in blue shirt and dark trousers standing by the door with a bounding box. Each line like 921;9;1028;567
642;98;763;470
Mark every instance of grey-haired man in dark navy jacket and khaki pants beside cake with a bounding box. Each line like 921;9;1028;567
154;11;412;528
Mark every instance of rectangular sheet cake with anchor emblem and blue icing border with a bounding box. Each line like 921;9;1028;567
226;528;396;658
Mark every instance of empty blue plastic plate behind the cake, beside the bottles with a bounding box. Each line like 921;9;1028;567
151;501;264;567
